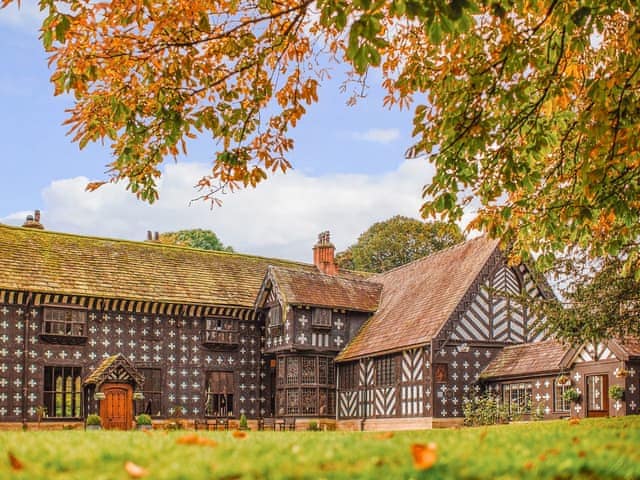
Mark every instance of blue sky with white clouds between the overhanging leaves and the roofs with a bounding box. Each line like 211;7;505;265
0;2;440;260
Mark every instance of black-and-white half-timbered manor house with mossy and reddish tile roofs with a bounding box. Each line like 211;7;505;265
0;217;640;430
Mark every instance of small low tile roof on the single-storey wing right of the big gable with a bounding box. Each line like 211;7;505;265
480;339;570;379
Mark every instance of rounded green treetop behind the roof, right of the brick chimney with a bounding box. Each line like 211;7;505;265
336;215;464;272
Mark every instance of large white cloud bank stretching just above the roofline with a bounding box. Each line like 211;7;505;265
5;159;452;262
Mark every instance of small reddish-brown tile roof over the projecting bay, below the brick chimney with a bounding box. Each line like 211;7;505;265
268;267;382;312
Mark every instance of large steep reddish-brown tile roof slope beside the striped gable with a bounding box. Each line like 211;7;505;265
337;237;498;361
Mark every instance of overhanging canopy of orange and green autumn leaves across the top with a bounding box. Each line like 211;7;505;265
1;0;640;270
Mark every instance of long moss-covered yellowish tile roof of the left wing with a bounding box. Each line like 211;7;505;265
0;225;316;308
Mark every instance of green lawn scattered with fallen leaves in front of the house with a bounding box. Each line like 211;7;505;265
0;416;640;480
